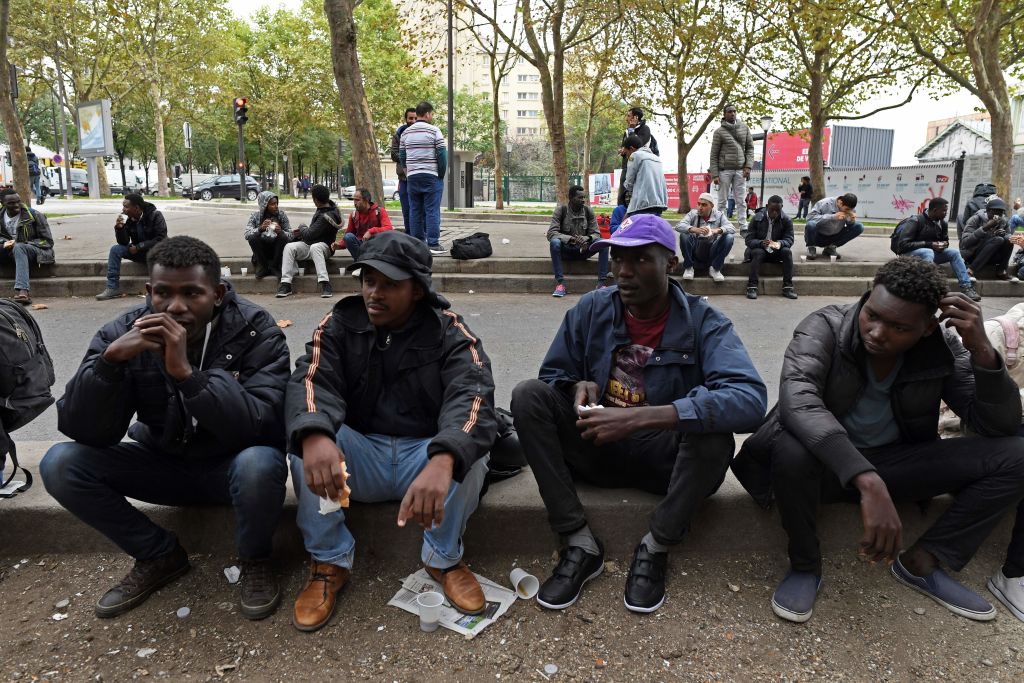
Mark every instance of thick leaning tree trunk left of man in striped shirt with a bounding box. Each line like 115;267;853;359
324;0;382;202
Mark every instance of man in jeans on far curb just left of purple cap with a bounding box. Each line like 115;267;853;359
547;185;608;297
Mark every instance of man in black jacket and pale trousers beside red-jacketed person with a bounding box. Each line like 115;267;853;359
276;185;341;299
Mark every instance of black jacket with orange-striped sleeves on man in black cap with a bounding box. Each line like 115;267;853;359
285;296;498;481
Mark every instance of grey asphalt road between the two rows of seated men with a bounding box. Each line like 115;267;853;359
14;293;1018;441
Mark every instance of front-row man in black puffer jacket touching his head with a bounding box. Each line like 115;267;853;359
732;258;1024;622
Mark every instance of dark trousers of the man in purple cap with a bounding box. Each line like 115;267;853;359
512;380;734;545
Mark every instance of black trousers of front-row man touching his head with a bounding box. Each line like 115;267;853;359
771;431;1024;575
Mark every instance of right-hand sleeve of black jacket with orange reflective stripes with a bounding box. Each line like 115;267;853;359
427;310;498;481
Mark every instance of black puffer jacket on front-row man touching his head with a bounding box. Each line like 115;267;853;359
732;294;1021;507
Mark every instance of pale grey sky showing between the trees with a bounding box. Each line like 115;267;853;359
227;0;981;167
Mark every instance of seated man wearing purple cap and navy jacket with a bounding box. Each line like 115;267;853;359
512;214;767;612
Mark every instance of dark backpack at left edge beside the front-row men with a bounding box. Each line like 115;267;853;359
0;299;54;498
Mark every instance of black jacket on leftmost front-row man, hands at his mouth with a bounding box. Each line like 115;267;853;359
57;285;289;458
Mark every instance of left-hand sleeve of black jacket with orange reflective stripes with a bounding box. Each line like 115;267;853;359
285;313;345;458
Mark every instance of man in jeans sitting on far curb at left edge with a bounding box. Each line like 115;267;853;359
0;189;55;306
